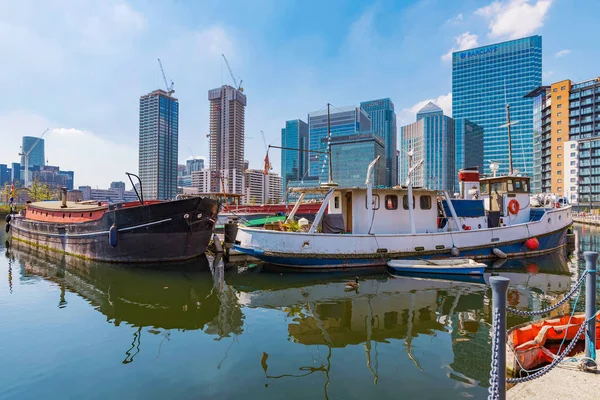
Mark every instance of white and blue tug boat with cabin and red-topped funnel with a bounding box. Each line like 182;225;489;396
234;158;573;270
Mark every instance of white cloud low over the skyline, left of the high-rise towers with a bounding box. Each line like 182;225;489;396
0;111;138;188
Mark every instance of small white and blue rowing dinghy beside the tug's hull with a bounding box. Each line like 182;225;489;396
387;258;486;275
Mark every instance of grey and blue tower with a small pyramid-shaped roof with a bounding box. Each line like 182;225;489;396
400;102;457;193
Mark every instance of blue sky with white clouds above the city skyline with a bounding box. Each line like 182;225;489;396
0;0;600;187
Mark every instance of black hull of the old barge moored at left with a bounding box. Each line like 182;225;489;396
10;197;219;263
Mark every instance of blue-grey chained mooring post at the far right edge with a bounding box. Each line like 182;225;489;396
583;251;598;367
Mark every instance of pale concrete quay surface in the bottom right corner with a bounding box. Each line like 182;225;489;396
506;354;600;400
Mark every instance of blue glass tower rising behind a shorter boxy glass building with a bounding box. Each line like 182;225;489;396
308;106;371;182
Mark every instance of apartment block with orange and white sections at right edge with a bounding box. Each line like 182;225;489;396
526;78;600;207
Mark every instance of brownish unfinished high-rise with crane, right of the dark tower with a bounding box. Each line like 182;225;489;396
208;85;246;194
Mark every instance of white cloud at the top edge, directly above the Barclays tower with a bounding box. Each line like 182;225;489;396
475;0;553;39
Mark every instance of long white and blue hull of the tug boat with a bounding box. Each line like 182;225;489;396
235;206;573;269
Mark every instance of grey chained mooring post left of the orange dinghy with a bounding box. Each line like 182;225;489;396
490;276;510;400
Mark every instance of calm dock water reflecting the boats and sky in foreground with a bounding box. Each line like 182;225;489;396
0;225;600;399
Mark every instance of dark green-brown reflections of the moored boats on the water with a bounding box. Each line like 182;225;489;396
0;227;578;398
